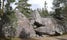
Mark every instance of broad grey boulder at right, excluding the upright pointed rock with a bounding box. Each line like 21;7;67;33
35;18;65;35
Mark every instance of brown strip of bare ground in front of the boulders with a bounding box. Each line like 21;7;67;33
1;34;67;40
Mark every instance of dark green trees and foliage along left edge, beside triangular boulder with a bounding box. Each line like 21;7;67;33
0;0;17;37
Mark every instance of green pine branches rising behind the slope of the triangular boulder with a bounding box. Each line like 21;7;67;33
17;0;31;17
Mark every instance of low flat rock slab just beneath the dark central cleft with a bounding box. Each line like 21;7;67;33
35;27;55;35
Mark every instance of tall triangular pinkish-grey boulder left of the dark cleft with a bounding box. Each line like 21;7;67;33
16;10;36;38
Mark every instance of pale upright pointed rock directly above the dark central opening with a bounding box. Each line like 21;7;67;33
31;11;42;24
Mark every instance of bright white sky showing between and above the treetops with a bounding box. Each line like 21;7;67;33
12;0;53;11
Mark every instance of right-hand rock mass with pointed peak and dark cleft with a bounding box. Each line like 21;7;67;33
32;11;65;35
